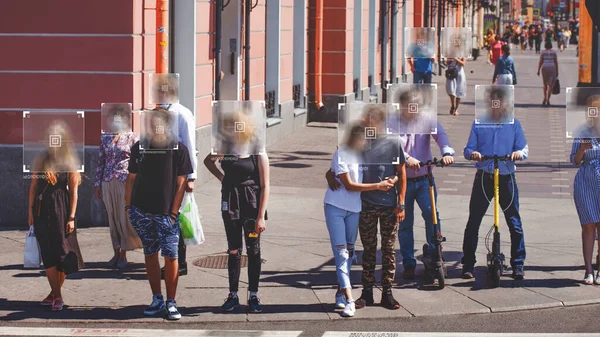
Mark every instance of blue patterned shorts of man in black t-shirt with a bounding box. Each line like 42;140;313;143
129;206;179;259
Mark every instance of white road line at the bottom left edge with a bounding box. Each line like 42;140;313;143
0;327;302;337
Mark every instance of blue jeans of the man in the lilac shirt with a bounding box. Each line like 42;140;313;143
398;179;440;269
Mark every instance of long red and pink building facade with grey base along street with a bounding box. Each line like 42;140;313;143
0;0;482;226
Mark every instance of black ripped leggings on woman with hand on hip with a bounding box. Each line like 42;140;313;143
225;220;261;292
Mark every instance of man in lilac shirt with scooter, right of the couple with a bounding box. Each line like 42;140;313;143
392;90;454;280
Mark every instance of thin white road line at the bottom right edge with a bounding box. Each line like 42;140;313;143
323;331;600;337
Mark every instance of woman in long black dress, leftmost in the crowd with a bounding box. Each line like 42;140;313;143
28;121;84;311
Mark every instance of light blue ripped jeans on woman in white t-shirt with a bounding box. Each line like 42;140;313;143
325;204;360;289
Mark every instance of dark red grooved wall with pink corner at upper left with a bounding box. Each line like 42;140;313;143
0;0;156;145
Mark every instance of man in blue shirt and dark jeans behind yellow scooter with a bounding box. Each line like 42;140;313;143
461;86;529;280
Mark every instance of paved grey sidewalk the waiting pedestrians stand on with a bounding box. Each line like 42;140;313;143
0;48;600;322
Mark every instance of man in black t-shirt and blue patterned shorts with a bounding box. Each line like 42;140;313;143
125;109;193;320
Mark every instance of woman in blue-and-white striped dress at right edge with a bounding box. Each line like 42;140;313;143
570;95;600;285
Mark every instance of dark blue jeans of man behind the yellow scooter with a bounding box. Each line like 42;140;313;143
461;170;525;268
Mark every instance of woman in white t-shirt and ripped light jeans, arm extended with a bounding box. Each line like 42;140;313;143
324;125;395;317
